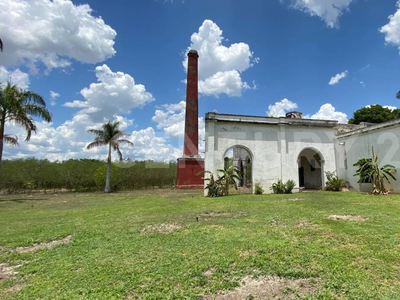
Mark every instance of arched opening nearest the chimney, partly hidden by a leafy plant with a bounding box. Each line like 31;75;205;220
224;146;253;194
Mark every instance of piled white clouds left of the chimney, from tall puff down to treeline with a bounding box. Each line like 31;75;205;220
4;65;179;161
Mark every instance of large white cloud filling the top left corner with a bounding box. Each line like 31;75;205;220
0;0;116;72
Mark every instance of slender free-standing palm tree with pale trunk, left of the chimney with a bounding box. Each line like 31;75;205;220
87;122;133;193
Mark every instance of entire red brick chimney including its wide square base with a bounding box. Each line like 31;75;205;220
176;50;204;189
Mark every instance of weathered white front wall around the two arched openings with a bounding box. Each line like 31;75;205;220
205;115;336;193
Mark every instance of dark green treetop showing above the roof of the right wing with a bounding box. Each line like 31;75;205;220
349;105;400;124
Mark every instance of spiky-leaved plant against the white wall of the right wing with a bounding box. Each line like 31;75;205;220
354;147;397;194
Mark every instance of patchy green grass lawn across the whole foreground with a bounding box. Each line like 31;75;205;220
0;190;400;300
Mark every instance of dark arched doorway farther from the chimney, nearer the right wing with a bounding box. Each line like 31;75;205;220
298;148;324;190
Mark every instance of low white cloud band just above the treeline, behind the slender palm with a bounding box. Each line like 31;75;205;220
4;113;182;161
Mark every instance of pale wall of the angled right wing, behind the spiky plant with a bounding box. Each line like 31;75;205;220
335;121;400;193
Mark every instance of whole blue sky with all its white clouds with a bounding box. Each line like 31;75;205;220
0;0;400;160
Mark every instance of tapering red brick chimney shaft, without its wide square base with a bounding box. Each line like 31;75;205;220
183;50;199;156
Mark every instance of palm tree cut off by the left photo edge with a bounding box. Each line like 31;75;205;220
0;82;51;169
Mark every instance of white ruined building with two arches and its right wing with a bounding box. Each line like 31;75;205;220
205;112;400;193
